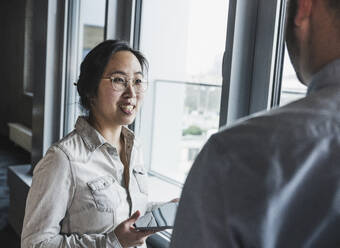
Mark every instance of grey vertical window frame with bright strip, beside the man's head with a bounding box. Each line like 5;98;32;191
249;0;286;114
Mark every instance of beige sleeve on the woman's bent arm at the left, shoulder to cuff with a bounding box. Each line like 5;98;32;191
21;146;121;248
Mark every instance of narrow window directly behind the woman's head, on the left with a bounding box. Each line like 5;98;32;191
64;0;106;135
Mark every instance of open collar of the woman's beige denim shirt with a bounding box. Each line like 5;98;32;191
75;116;135;152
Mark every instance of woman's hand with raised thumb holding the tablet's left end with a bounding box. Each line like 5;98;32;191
114;210;155;248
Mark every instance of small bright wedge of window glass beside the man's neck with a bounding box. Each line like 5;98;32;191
280;49;307;105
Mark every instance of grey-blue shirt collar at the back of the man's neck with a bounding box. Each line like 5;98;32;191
307;59;340;95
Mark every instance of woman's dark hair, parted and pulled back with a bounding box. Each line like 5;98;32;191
77;40;148;110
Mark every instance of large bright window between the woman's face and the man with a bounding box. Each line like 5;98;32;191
136;0;228;200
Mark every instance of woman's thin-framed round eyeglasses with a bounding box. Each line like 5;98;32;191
103;74;148;93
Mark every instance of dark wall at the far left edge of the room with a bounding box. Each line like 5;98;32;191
0;0;32;135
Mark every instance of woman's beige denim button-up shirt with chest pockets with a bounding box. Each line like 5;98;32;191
21;117;158;248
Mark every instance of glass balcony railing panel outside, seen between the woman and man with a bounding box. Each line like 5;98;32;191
151;80;221;182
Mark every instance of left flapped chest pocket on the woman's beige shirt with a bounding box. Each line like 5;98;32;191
87;176;121;212
